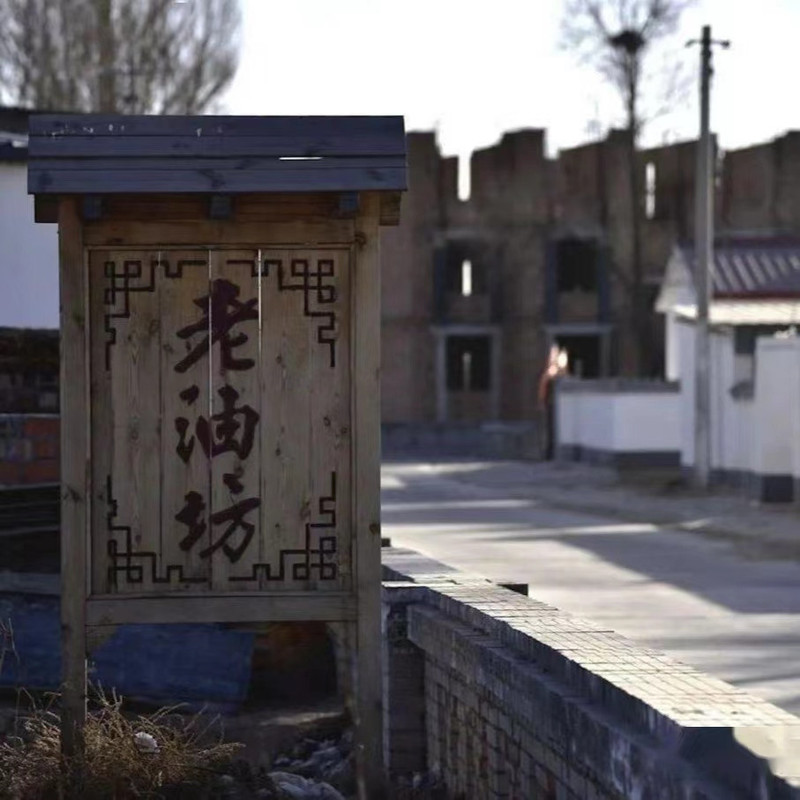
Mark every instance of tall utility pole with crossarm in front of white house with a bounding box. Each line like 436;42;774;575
689;25;730;489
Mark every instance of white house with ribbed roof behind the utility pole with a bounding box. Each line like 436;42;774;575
656;236;800;501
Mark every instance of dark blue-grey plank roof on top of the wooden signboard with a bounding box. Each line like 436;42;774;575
28;114;407;195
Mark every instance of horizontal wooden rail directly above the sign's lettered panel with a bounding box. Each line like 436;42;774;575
84;220;355;247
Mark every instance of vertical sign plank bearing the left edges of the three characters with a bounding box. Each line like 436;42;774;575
157;250;211;590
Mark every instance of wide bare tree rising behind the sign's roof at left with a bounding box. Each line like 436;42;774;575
0;0;241;114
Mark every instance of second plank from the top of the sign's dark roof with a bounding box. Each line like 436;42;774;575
29;131;405;159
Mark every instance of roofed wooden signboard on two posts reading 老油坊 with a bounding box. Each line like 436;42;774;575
29;116;405;797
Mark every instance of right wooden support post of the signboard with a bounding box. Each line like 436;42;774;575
351;195;386;800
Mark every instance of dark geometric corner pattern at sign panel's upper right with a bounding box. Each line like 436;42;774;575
261;258;338;367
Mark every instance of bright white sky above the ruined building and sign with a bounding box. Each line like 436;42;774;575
223;0;800;161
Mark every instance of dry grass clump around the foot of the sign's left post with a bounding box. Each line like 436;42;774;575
0;693;239;800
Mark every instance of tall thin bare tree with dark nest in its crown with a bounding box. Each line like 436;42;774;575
561;0;692;374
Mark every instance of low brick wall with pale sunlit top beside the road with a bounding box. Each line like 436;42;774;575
384;550;800;800
